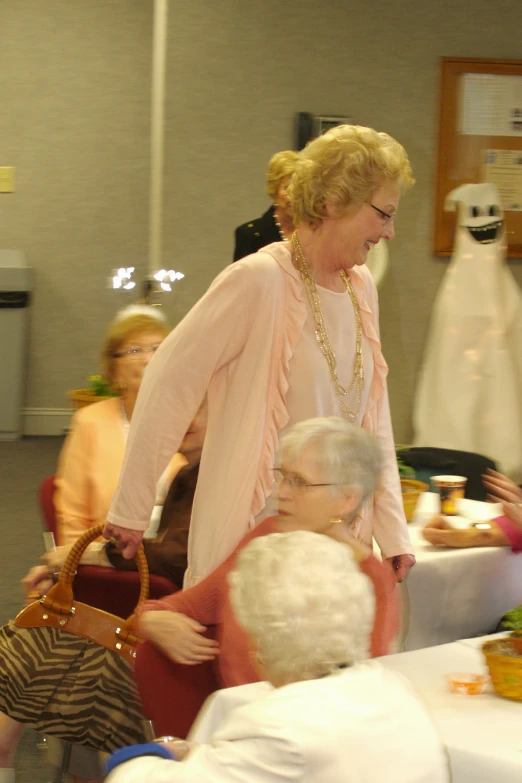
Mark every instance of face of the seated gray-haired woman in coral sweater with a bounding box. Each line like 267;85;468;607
276;446;358;533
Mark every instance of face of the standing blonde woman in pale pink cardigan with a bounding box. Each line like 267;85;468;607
323;182;400;269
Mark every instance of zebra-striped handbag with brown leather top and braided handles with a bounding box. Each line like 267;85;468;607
0;524;149;753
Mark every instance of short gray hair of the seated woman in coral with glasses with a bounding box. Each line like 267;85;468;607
281;416;382;504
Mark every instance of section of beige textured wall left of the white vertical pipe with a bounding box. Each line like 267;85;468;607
0;0;152;408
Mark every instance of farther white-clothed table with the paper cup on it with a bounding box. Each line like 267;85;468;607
401;492;522;651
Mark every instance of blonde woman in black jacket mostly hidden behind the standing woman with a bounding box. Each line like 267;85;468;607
234;150;299;261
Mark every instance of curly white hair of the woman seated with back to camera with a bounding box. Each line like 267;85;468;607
228;530;375;682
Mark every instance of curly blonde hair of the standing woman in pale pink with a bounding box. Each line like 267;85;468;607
288;125;415;227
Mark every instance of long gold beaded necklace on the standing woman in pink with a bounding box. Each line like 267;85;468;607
292;231;364;419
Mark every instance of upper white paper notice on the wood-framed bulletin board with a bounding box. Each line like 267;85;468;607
457;73;522;138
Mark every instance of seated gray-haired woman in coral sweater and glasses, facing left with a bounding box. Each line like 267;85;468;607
140;417;398;692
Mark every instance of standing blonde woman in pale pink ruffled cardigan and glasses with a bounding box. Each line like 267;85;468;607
105;125;415;585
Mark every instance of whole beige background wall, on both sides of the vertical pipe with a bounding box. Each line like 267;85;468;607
0;0;522;441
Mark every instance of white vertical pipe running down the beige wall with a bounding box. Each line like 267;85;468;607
147;0;168;275
